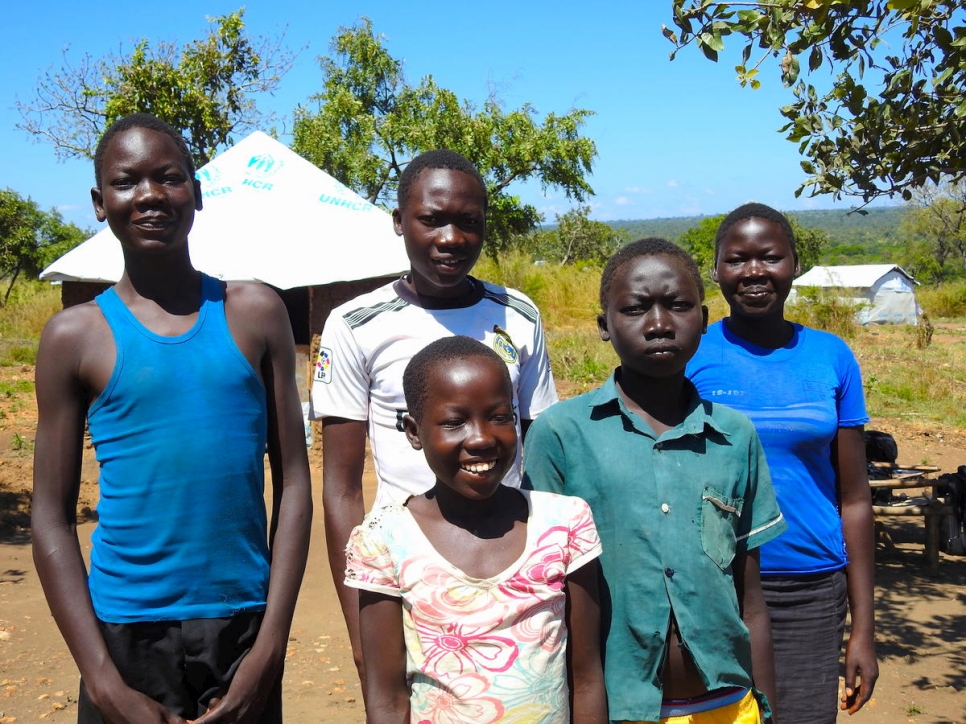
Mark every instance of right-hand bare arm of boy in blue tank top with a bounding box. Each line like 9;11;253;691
197;285;312;724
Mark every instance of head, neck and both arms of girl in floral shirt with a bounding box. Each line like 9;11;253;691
360;358;607;724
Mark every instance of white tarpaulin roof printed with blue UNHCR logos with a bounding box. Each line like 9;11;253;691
40;131;409;289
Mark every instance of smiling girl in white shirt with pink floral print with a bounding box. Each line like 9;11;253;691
346;337;607;724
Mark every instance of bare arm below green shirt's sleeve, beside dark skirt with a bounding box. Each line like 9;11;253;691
734;548;778;722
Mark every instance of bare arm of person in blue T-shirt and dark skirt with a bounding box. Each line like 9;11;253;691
832;427;879;714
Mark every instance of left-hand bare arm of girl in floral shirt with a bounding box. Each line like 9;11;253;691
362;589;410;724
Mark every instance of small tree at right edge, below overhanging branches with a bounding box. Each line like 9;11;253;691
899;181;966;283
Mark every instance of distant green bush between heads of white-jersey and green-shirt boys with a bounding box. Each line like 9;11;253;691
520;206;626;266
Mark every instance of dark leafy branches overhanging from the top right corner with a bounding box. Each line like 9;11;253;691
664;0;966;203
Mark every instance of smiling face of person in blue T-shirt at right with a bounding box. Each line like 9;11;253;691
712;217;799;318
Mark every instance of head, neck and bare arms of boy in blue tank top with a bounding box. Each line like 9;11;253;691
31;128;312;724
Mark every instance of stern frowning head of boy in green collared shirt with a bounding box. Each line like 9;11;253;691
597;254;708;377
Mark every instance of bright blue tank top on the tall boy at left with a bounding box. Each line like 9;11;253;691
87;276;269;623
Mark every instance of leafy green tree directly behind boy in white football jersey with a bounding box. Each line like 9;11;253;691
292;18;597;251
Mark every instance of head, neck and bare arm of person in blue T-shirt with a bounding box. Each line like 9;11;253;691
713;217;879;714
